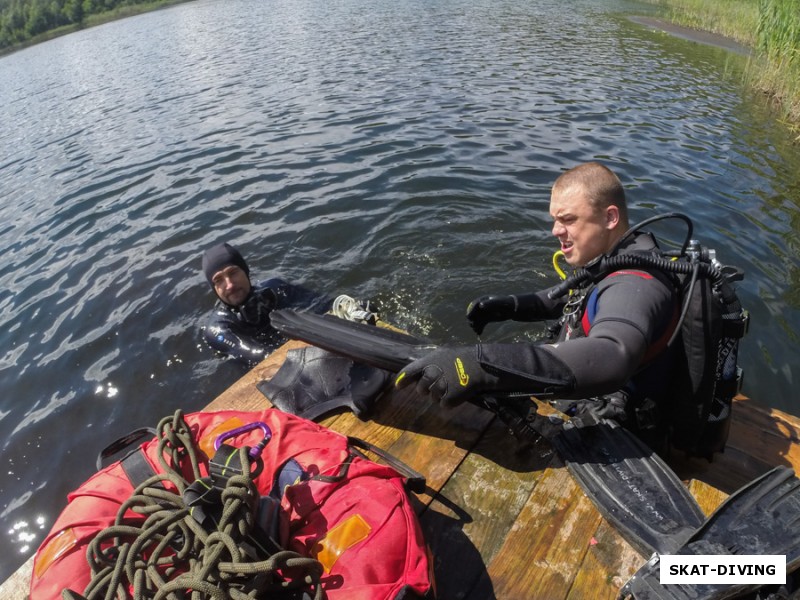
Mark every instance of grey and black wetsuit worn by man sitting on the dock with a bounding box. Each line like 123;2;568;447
490;233;679;430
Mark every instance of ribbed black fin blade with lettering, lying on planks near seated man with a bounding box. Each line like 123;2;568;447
550;419;704;556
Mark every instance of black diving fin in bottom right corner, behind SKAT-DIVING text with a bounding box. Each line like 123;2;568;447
620;467;800;600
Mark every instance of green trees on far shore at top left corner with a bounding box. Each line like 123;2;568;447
0;0;153;50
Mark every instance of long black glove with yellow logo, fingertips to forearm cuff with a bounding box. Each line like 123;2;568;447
395;344;575;406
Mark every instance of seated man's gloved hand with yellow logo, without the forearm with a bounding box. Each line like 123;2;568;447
395;346;496;407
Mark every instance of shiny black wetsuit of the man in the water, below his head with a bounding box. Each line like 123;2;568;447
203;278;331;366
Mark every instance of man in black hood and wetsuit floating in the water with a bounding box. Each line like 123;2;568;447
203;244;331;366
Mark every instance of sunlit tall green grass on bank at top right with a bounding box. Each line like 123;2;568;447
644;0;800;141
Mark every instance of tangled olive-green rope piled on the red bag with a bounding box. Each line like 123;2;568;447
62;410;325;600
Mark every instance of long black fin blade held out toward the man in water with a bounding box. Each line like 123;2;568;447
270;309;436;373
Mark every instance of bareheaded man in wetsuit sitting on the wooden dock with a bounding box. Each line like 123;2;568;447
396;163;678;443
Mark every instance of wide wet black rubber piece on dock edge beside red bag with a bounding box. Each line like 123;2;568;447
256;346;390;421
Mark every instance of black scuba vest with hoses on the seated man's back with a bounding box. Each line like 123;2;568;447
550;213;749;460
